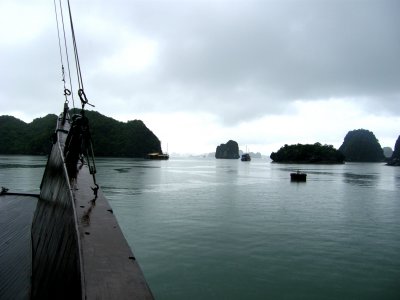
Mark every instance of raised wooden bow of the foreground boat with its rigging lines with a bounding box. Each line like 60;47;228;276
30;1;153;299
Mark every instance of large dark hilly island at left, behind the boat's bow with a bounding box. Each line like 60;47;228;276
0;110;162;158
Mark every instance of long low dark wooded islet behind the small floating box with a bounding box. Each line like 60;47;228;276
270;143;344;164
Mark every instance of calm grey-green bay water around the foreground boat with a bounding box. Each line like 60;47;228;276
0;156;400;300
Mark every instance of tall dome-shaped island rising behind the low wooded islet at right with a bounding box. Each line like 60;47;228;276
339;129;385;162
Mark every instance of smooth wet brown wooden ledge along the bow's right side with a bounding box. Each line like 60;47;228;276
73;166;153;299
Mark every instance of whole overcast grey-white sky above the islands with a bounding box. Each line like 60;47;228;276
0;0;400;155
